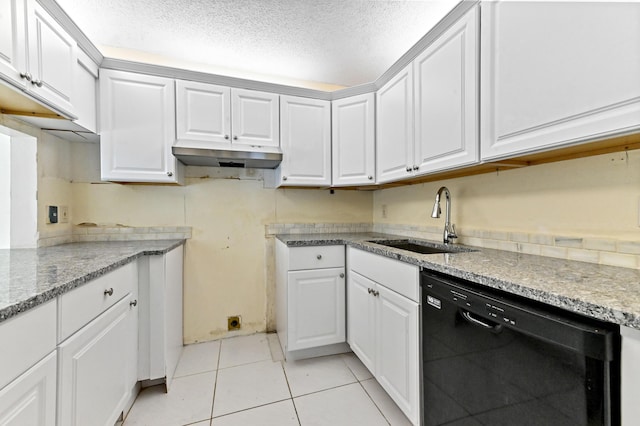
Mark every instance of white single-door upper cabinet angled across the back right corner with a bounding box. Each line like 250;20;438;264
331;93;376;186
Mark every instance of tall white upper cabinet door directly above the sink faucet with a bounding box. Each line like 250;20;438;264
413;6;480;174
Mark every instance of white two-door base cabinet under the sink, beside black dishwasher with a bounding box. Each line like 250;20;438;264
347;248;420;425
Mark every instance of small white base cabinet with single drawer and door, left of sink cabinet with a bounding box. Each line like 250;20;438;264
276;240;349;360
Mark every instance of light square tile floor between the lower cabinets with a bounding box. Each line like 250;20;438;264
124;334;410;426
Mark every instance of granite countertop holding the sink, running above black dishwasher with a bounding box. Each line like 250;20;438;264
277;233;640;329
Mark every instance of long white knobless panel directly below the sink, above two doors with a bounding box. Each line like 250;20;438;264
347;247;420;303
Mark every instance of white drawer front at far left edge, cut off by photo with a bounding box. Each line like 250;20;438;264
0;300;56;389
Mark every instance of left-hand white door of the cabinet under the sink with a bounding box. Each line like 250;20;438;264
347;271;377;372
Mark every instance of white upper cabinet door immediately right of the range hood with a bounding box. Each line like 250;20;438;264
279;96;331;186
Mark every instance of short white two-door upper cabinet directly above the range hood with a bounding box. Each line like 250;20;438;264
176;80;280;151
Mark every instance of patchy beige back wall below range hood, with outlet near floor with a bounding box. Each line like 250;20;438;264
72;150;373;343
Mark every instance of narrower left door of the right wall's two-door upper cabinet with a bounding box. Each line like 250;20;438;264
376;64;413;183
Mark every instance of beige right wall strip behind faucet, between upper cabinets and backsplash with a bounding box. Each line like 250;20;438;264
373;150;640;240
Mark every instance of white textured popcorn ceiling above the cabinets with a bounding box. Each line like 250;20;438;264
57;0;458;90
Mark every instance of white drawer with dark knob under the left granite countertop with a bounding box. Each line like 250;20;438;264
58;262;138;342
